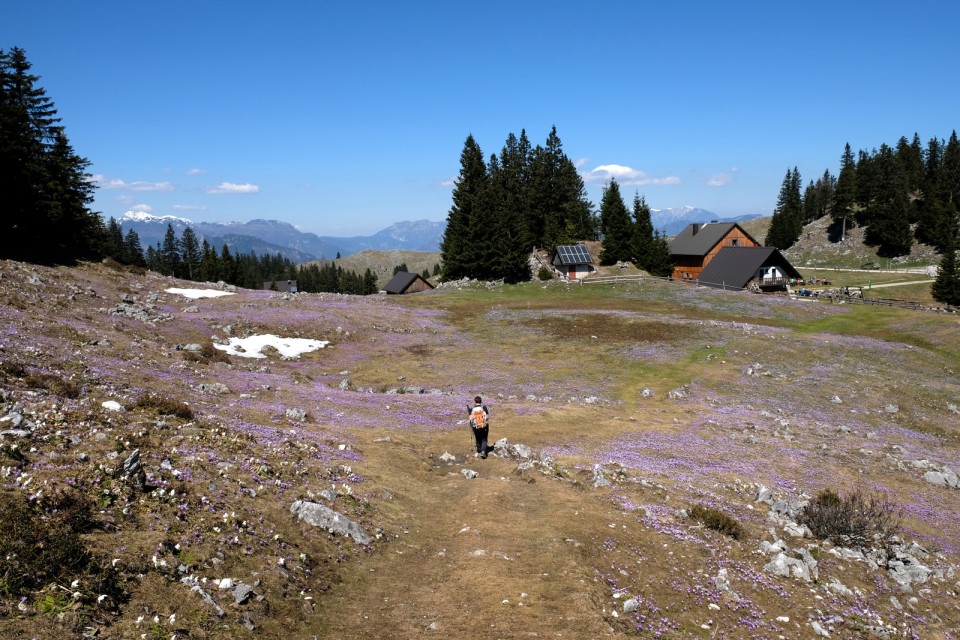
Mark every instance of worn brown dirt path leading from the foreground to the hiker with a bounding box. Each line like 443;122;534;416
308;424;611;639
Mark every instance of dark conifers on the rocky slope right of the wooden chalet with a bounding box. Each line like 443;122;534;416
765;130;960;305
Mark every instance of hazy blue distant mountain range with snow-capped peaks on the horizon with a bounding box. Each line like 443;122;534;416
119;207;760;262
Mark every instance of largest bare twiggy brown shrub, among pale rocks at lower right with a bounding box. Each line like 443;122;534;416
797;489;902;547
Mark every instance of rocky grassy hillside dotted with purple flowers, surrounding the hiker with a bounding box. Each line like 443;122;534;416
0;262;960;640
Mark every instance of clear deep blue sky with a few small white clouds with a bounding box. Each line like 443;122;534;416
7;0;960;236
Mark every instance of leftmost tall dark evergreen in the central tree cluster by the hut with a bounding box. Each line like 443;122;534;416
440;135;489;280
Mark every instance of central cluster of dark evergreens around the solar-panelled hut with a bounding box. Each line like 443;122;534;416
440;127;669;282
